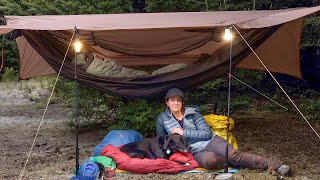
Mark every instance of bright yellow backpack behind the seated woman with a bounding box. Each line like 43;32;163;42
203;114;238;150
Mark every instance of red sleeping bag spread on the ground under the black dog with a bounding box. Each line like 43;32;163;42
100;145;199;174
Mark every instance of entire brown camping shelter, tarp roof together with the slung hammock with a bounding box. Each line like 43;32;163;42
0;6;320;98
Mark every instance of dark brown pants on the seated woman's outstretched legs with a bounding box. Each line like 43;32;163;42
194;135;281;170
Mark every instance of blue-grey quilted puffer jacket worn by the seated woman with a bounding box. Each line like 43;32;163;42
156;107;213;154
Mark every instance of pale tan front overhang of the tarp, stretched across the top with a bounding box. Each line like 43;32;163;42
0;6;320;33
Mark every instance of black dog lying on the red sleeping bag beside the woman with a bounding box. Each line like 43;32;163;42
120;134;189;159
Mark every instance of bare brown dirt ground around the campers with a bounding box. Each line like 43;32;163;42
0;90;320;180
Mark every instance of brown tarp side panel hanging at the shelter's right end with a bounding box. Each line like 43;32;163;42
237;18;303;78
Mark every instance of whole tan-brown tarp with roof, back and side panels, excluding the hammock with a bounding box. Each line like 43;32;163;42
0;6;320;79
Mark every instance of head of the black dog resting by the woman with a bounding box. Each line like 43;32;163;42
163;134;189;154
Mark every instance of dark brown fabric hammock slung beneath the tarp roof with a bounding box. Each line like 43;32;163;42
21;26;279;98
